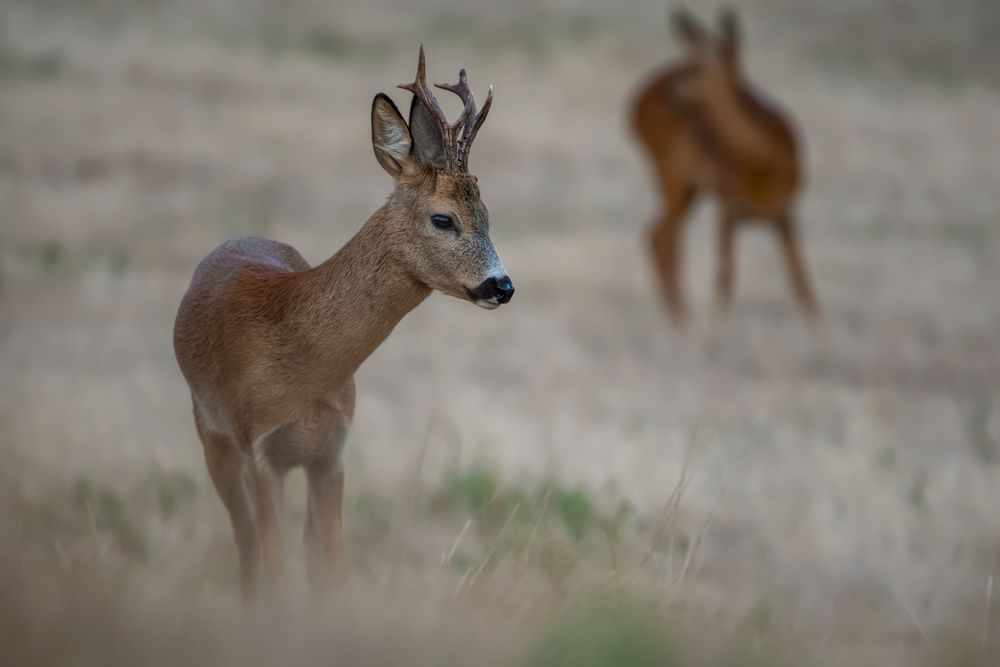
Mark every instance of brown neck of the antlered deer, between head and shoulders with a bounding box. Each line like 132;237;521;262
292;205;431;389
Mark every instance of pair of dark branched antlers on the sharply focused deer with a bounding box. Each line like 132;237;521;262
397;44;493;173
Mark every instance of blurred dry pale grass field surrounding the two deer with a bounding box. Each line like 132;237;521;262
0;0;1000;665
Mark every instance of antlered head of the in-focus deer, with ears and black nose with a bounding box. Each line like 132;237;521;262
372;46;514;309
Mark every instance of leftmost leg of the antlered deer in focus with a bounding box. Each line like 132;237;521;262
195;409;260;601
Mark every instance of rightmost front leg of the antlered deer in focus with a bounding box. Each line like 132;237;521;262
305;456;344;588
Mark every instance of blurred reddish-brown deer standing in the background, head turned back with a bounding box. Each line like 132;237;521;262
632;10;819;322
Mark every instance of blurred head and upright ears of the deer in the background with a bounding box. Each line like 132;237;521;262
670;8;742;105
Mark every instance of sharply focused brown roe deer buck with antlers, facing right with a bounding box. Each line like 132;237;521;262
174;46;514;598
